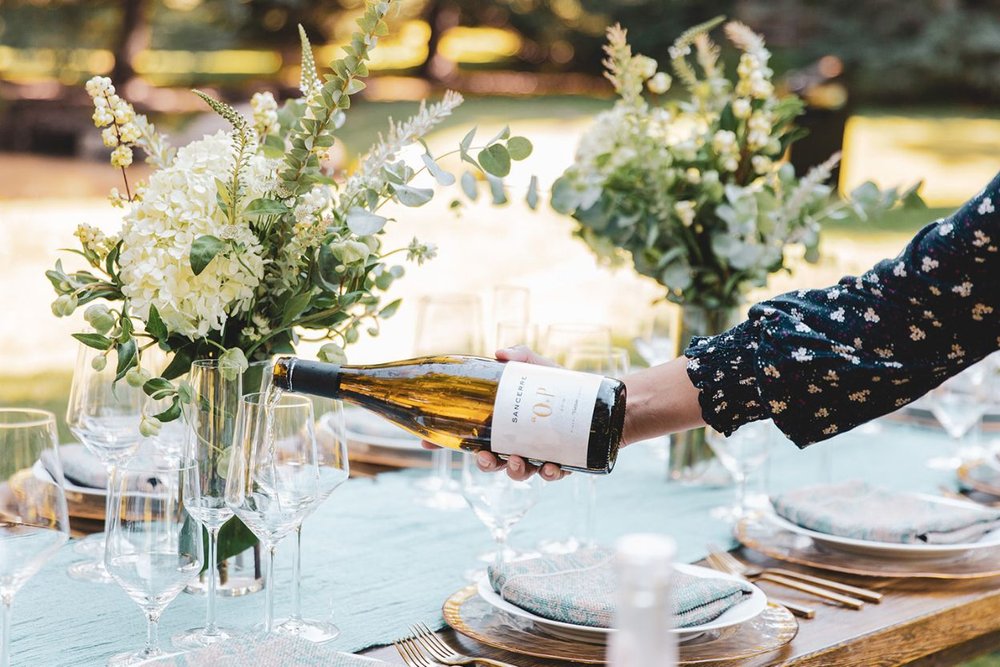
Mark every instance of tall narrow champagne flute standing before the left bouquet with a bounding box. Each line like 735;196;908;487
172;359;243;649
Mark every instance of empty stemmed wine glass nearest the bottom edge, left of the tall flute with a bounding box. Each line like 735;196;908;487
104;454;204;667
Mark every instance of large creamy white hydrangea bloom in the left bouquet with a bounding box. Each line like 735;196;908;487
121;132;273;338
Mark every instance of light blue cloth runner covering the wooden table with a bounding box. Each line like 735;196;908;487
12;426;954;667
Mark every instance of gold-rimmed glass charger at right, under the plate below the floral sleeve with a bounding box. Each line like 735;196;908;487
736;516;1000;579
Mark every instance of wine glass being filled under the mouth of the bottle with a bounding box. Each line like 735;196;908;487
226;394;320;634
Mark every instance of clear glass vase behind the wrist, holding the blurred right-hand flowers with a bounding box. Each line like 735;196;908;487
667;305;741;486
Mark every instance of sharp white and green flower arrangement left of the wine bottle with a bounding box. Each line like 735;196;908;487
47;0;537;434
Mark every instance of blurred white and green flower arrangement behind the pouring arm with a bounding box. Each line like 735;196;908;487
552;18;920;308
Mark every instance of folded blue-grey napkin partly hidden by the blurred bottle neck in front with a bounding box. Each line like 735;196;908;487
489;547;751;628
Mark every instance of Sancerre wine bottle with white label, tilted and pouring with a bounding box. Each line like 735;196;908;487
273;355;625;474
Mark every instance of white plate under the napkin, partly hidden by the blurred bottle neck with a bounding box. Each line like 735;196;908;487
478;563;767;643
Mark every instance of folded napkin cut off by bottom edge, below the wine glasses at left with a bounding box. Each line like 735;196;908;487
140;636;389;667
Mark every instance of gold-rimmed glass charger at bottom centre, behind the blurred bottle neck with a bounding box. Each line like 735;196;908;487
443;586;799;665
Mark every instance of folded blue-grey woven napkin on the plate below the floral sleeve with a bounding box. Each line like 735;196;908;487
771;480;1000;544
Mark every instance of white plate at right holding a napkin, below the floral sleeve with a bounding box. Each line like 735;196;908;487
764;493;1000;559
